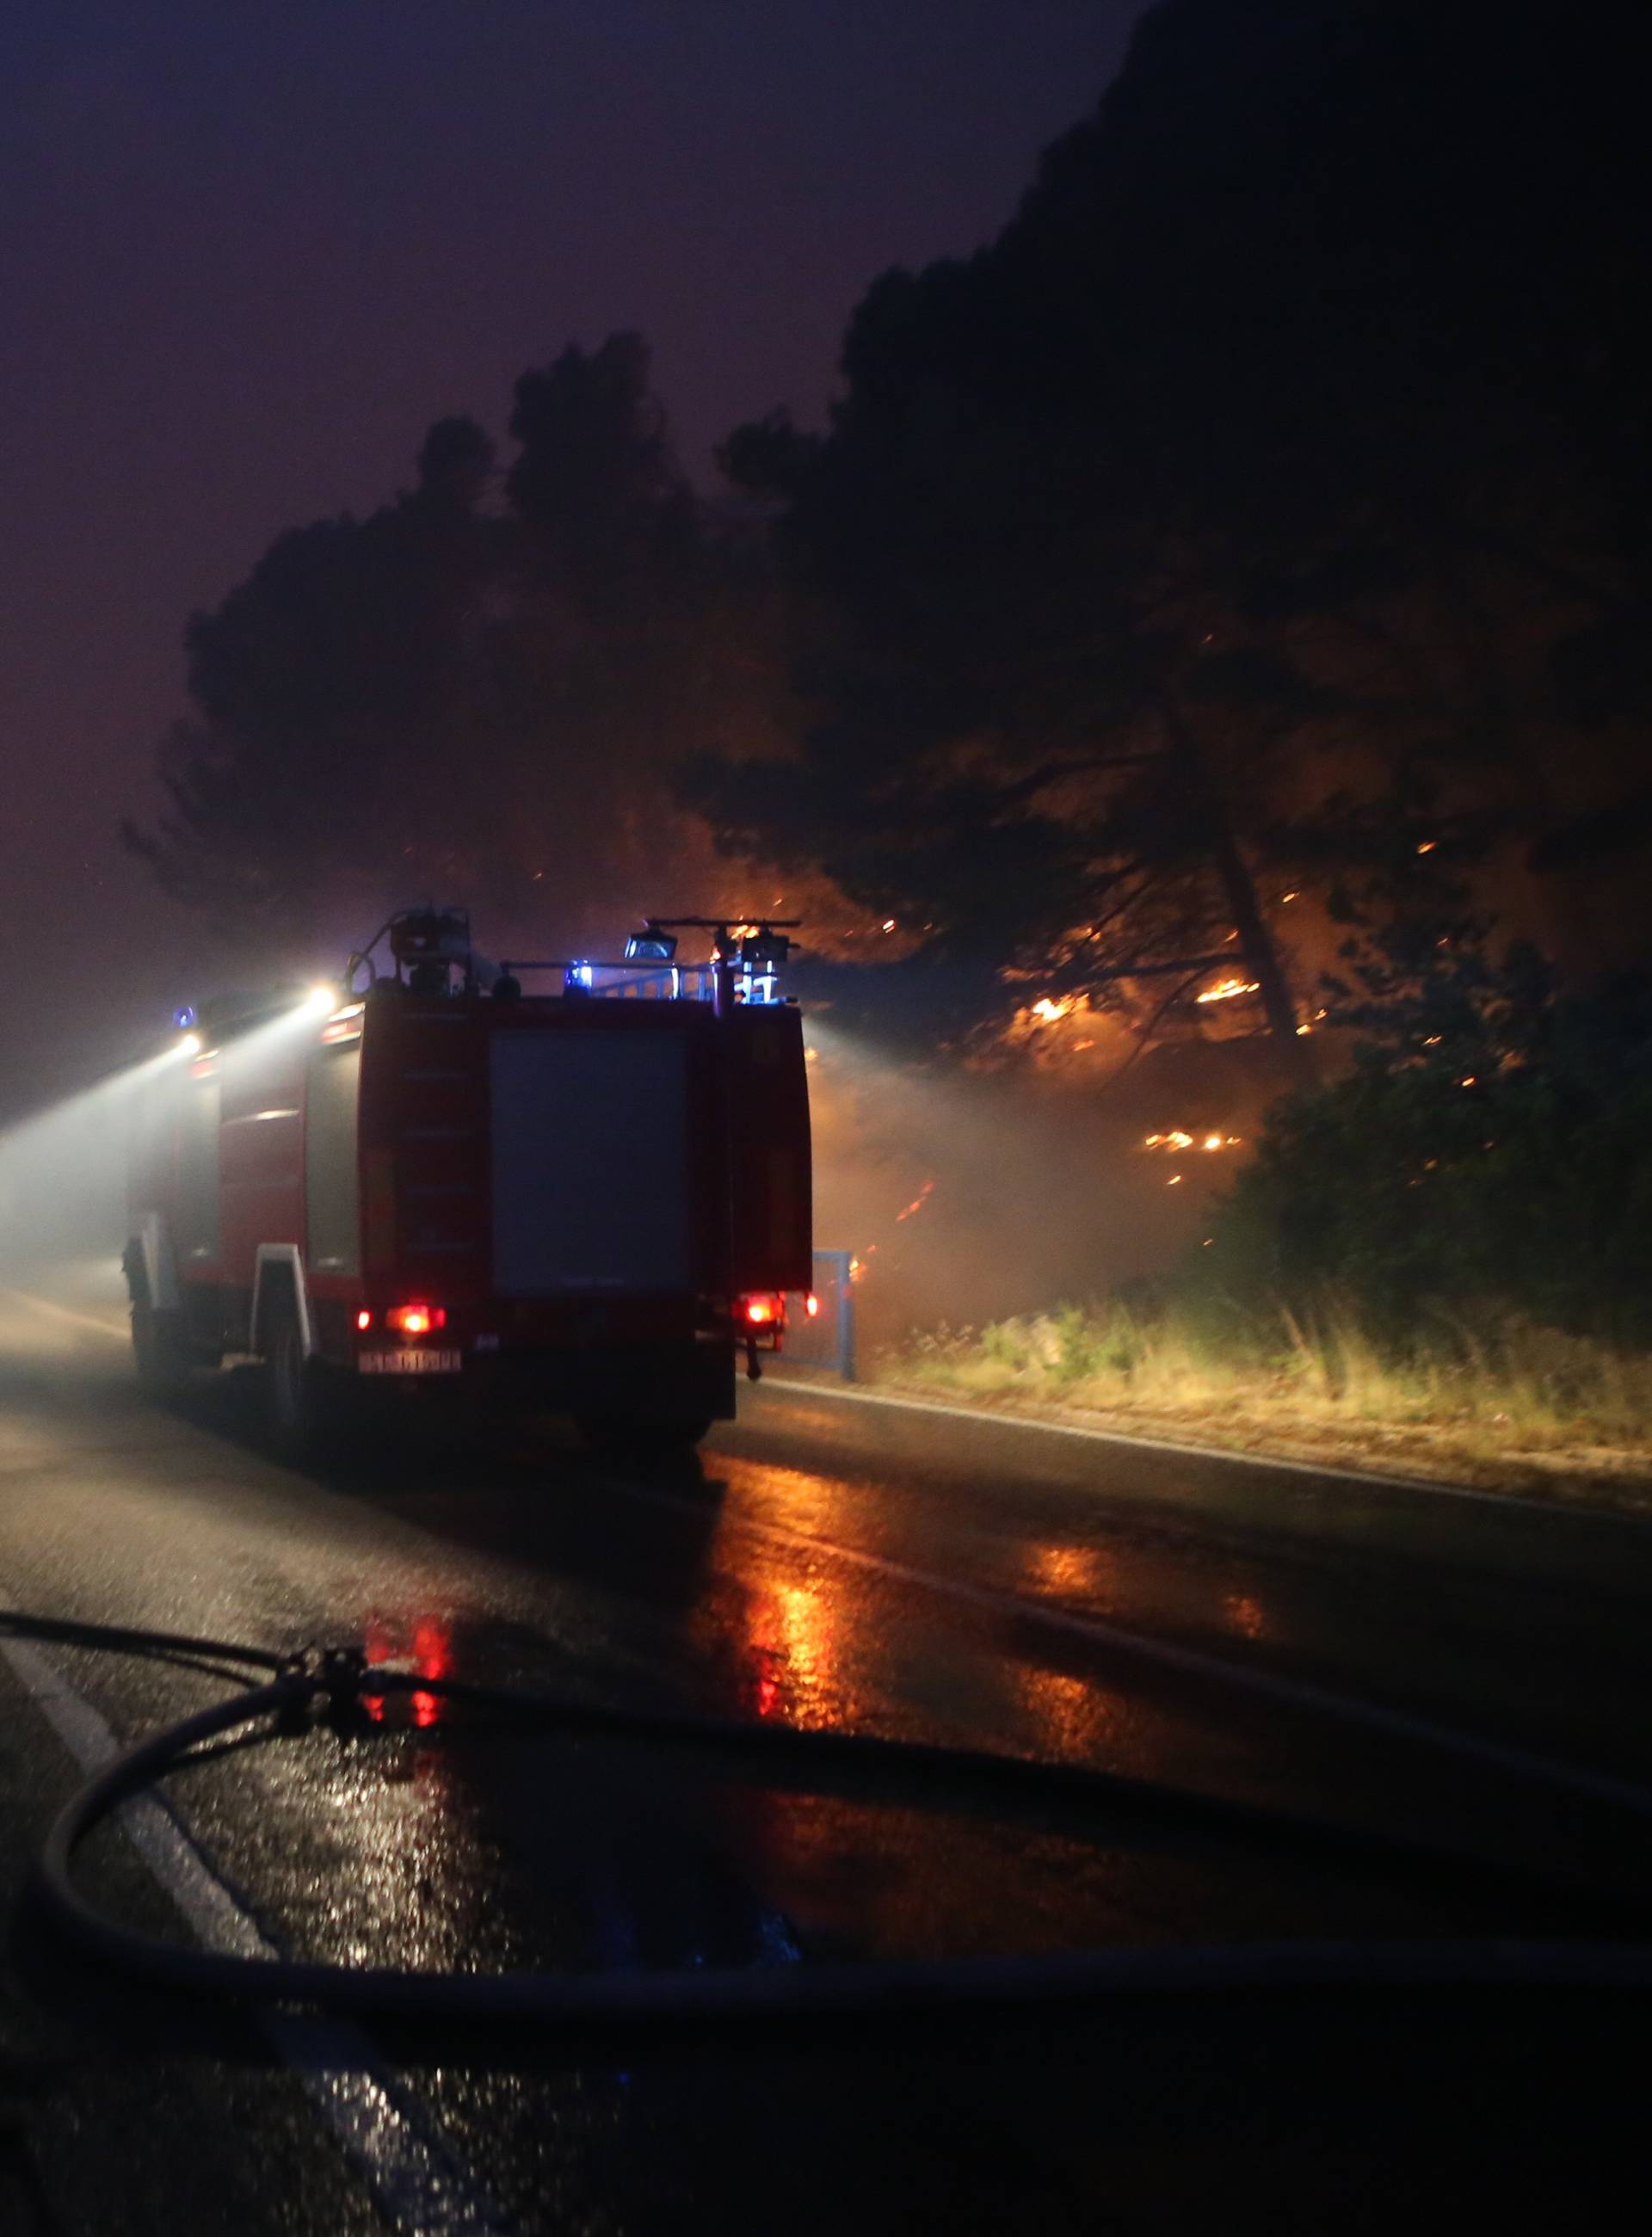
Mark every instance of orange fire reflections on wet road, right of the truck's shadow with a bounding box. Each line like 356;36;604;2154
680;1451;1316;1787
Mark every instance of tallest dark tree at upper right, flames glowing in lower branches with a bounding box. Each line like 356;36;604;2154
692;0;1652;1078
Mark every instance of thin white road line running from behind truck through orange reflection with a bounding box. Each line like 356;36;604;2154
602;1476;1652;1819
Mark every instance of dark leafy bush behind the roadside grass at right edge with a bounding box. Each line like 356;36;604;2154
1180;928;1652;1356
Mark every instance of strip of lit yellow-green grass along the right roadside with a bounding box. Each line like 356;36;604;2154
871;1297;1652;1510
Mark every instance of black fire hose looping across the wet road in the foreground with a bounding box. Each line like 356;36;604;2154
0;1611;1652;2024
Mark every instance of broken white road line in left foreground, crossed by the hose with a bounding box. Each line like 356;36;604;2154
0;1630;510;2237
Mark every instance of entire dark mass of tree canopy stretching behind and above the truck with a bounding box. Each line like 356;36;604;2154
130;0;1652;1081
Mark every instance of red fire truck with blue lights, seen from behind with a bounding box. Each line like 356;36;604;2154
126;910;812;1454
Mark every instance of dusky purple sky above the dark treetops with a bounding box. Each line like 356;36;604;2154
0;0;1139;1110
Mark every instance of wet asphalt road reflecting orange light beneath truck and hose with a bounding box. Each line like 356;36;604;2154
0;1297;1652;2237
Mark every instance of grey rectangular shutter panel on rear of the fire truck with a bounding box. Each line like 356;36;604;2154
488;1026;692;1297
